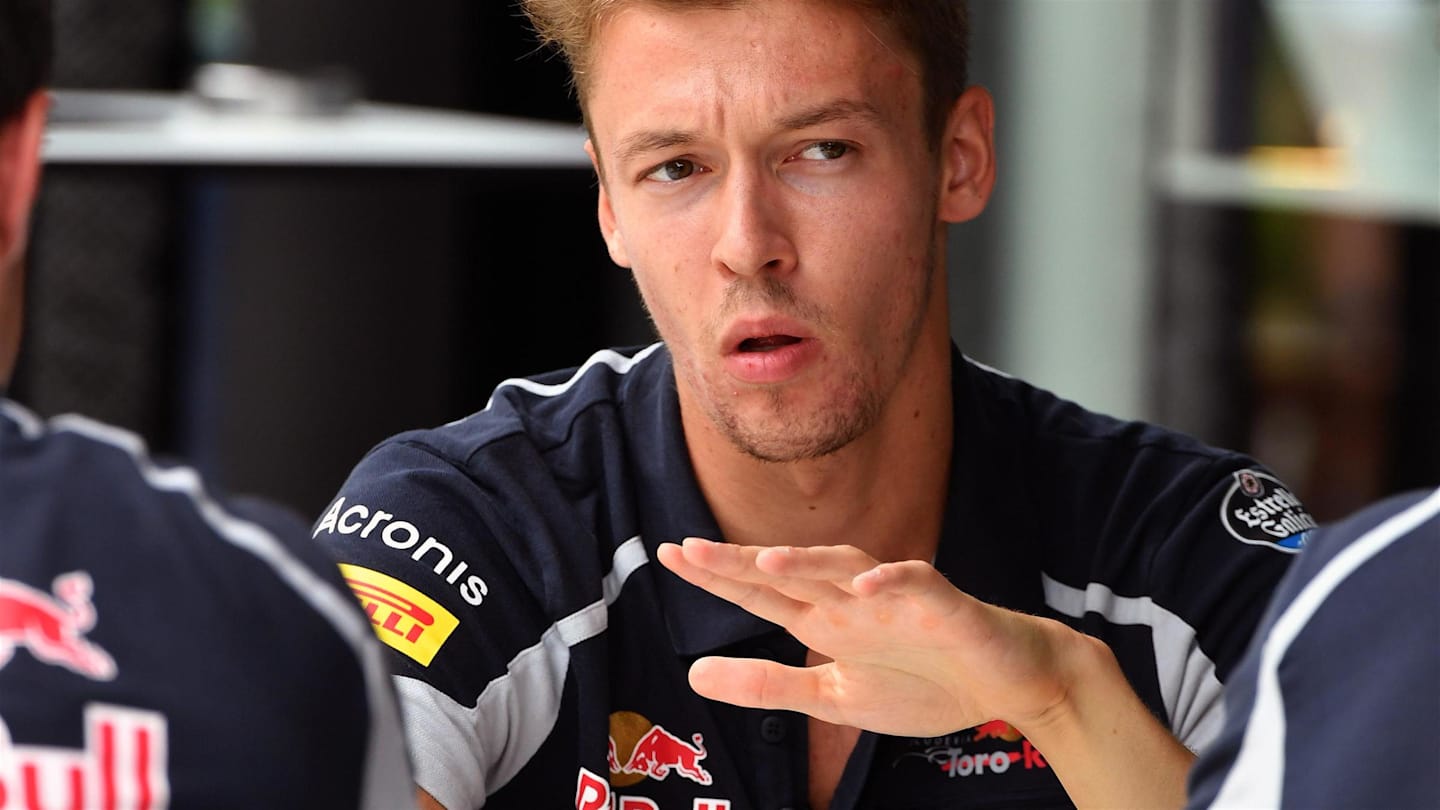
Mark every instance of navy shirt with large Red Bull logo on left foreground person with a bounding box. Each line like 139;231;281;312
0;399;415;810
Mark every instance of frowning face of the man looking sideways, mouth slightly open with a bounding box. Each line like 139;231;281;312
586;0;946;461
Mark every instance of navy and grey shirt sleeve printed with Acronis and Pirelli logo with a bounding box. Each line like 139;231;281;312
314;441;567;810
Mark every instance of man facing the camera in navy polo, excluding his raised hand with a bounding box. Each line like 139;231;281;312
315;0;1312;810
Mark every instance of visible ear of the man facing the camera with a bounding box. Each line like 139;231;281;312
940;86;995;222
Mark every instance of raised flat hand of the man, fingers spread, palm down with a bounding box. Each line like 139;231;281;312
660;538;1094;736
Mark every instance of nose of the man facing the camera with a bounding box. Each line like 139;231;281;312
713;173;796;275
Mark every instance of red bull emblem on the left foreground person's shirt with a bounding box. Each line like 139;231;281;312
0;571;115;680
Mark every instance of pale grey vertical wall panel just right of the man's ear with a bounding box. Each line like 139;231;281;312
981;0;1155;418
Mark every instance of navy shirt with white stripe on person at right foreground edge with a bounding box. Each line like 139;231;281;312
1189;481;1440;809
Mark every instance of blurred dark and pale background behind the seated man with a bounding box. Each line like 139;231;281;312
10;0;1440;519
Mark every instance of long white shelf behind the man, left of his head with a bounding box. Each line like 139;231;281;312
43;91;589;169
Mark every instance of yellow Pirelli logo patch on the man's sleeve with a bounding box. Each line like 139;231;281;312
340;562;459;666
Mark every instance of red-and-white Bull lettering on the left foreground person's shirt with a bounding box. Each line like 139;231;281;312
0;703;170;810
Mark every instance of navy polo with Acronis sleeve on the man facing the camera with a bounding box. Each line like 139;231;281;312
315;344;1313;810
